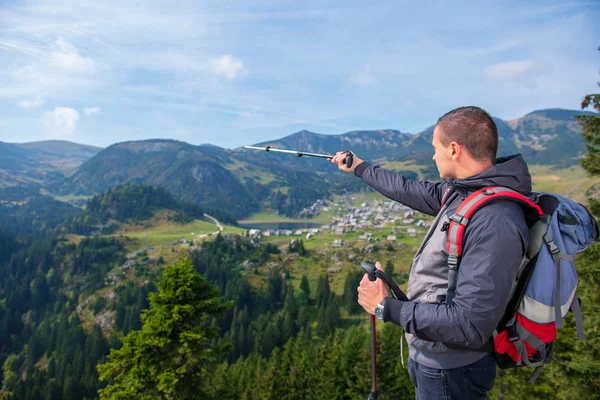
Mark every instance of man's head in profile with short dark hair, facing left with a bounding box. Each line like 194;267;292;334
431;106;498;179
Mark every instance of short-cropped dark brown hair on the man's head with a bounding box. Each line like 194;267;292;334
437;106;498;162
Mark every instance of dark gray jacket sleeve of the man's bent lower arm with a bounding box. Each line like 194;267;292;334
384;202;528;348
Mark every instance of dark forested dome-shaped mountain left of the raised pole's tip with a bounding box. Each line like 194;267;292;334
61;140;259;214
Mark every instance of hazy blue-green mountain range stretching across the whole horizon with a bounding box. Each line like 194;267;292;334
0;109;596;217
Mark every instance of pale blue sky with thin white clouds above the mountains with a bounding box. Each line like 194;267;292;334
0;0;600;149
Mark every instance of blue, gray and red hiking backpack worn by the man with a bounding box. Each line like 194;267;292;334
444;186;598;382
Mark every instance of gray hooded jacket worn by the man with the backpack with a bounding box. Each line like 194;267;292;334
354;155;531;369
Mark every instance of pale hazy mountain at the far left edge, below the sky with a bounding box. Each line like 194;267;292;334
0;140;102;188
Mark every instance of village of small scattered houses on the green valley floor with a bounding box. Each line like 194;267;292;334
248;197;430;246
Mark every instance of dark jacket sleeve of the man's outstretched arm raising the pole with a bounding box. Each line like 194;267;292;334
354;162;448;215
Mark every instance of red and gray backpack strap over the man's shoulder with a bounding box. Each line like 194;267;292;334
446;186;544;304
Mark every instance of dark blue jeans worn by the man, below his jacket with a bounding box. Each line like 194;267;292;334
408;353;496;400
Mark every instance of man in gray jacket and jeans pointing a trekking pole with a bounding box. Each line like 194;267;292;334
332;107;531;400
